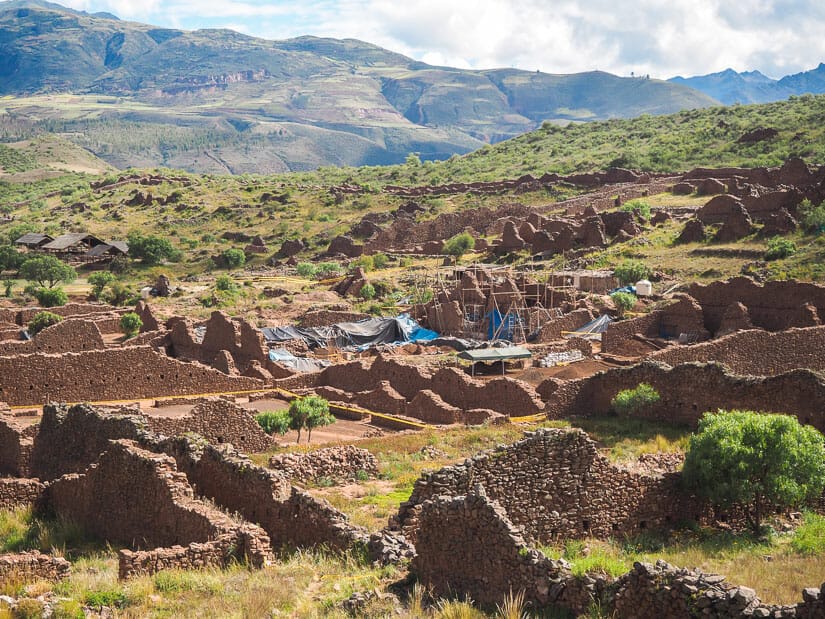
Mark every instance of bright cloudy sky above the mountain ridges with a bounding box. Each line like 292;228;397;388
57;0;825;78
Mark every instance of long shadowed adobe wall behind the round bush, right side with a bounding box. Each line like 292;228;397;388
538;360;825;431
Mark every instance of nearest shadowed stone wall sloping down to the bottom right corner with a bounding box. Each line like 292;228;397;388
410;488;825;619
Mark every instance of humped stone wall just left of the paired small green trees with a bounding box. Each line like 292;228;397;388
146;398;275;453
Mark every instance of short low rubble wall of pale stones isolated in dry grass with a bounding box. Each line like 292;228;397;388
269;445;378;482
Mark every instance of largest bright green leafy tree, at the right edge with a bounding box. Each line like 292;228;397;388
683;410;825;533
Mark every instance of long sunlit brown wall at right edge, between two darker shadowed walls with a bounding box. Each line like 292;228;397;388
649;326;825;376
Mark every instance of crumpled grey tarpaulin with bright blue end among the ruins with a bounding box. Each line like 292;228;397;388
261;314;438;350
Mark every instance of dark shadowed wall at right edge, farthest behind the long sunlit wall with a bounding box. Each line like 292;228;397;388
687;277;825;333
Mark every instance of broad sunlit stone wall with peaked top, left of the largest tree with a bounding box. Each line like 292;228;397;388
398;429;704;543
